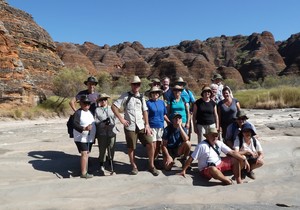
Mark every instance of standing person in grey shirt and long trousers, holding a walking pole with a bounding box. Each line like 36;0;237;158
95;93;118;175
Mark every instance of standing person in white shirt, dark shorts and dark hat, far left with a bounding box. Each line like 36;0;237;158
73;95;96;179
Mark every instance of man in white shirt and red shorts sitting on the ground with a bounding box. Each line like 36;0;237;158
180;128;250;185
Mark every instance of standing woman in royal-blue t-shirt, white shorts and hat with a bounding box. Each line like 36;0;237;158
147;86;170;159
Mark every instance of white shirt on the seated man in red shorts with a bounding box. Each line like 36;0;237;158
191;140;232;171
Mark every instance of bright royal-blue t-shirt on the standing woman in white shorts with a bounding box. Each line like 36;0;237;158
147;99;167;128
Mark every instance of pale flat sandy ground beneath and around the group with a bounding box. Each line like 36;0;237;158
0;109;300;209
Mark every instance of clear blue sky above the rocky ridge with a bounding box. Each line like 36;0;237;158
7;0;300;47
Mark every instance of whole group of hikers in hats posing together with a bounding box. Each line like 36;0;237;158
70;74;263;184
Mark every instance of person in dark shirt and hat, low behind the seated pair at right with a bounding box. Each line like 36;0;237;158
224;110;256;148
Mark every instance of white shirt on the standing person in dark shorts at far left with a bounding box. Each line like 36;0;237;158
73;110;96;143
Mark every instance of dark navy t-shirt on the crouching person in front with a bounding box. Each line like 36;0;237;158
162;124;187;149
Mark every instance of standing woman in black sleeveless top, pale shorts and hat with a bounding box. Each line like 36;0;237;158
193;86;219;144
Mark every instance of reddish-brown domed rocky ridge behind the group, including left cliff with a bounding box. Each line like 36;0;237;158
0;0;300;106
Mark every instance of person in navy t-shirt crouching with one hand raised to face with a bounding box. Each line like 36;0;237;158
162;113;191;170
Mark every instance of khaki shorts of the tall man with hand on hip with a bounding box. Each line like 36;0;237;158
124;128;152;149
